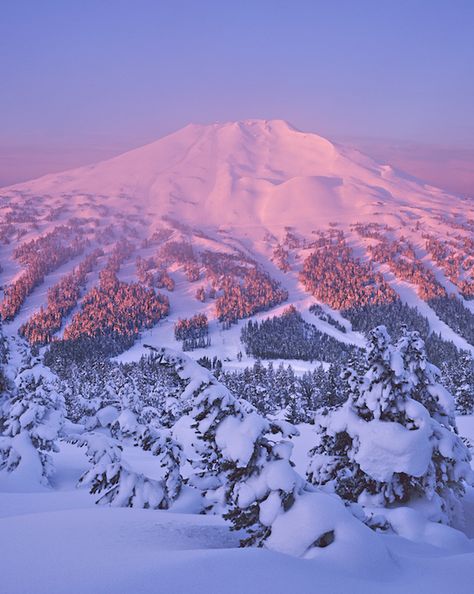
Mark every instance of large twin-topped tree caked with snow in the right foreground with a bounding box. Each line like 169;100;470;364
308;326;471;523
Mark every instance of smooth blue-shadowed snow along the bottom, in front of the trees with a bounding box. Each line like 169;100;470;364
0;417;474;594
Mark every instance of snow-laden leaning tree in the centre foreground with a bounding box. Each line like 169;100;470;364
185;356;306;546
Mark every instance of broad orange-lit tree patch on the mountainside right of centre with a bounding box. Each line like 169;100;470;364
300;231;398;310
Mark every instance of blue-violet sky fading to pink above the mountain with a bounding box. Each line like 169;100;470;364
0;0;474;193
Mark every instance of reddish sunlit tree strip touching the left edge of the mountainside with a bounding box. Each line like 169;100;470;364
0;226;85;320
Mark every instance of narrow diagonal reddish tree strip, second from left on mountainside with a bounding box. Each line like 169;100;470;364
19;249;104;345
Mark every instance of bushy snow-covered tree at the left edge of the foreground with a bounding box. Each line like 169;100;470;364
0;374;64;485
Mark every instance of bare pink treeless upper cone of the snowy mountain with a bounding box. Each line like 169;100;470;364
4;120;465;231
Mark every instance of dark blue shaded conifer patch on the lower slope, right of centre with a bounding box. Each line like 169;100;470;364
241;306;355;362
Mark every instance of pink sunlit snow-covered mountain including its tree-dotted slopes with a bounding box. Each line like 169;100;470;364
0;120;474;358
